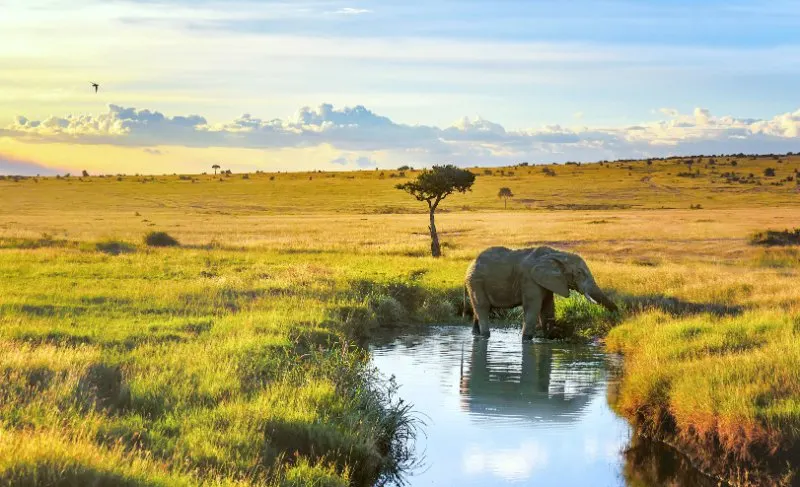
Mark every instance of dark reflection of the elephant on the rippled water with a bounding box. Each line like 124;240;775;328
460;339;603;423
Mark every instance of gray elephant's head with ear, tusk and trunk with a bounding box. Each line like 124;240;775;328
530;247;617;311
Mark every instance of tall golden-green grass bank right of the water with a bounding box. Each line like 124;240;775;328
606;309;800;485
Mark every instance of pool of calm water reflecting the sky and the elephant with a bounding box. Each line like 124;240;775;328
373;326;630;486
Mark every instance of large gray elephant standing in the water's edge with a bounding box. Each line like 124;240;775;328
464;247;617;340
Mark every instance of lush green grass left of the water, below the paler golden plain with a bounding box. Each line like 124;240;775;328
0;247;454;485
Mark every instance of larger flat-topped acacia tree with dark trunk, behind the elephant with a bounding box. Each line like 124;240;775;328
395;164;475;257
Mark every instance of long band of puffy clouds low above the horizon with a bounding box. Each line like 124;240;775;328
0;104;800;167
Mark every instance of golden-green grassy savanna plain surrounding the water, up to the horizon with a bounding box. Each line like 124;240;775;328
0;155;800;486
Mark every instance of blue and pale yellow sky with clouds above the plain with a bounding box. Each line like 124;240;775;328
0;0;800;174
